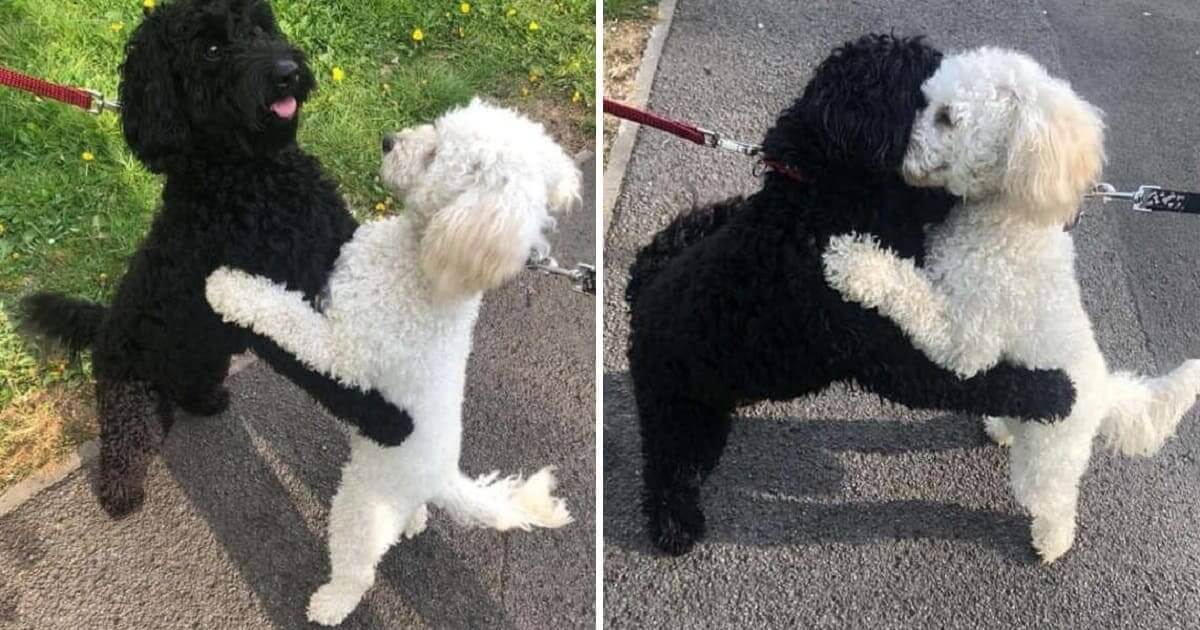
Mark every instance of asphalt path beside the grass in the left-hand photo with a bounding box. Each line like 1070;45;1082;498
0;156;595;630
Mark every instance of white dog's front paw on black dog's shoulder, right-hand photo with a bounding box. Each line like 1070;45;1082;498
821;233;899;307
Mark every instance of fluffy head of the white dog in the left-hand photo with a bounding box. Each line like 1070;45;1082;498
380;98;581;296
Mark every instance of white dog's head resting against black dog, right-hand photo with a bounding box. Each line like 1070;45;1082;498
904;48;1104;224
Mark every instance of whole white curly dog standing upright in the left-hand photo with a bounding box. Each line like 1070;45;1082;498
206;100;581;625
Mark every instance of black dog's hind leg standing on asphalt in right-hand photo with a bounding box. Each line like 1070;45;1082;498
637;391;731;556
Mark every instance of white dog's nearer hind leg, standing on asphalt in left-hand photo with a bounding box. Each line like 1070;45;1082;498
308;436;424;625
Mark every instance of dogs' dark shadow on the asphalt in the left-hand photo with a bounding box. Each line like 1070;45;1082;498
162;366;511;629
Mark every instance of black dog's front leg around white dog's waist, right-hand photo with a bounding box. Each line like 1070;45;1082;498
856;331;1075;422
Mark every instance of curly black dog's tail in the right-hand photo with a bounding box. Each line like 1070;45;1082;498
625;197;745;305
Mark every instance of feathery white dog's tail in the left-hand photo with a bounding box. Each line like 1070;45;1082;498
433;467;572;532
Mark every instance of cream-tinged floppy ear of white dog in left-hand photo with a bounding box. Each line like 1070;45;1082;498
421;191;540;298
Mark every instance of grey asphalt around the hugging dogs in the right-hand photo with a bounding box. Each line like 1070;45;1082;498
604;0;1200;629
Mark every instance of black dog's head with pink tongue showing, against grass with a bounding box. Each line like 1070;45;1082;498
120;0;316;173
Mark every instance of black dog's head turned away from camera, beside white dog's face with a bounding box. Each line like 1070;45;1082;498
763;35;942;180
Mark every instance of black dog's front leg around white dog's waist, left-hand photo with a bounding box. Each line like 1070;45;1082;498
250;334;413;446
